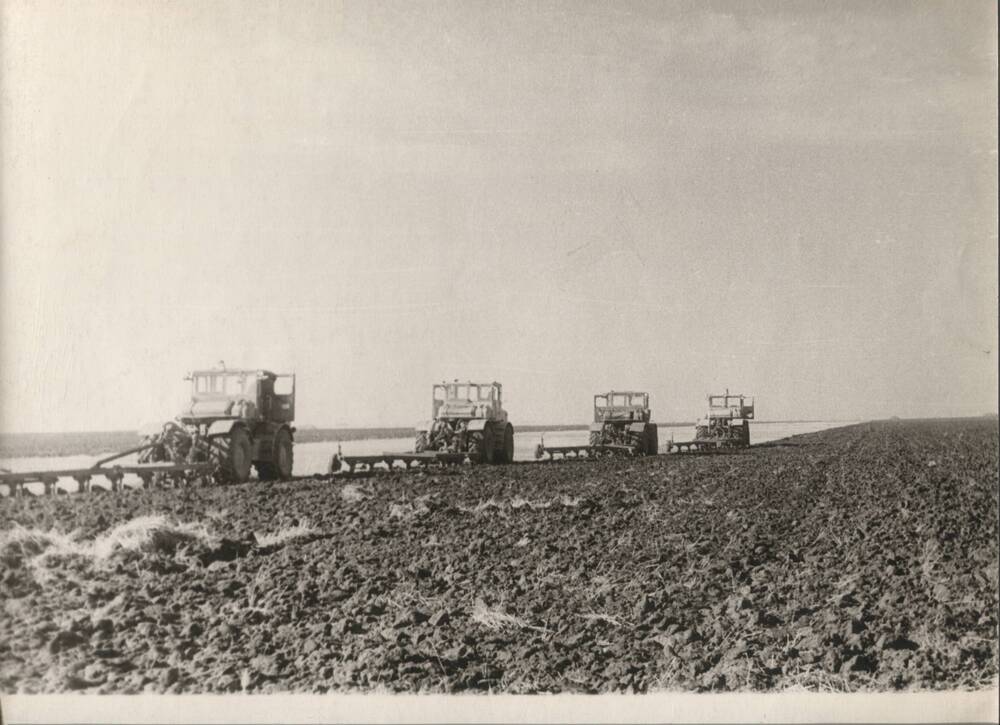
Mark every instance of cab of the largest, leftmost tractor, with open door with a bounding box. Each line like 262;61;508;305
181;368;295;423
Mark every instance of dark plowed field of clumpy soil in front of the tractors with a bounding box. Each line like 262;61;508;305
0;420;998;693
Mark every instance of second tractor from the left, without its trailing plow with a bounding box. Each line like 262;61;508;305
414;380;514;463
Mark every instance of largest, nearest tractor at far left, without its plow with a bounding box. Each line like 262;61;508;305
139;366;295;483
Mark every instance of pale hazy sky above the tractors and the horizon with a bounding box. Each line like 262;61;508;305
0;0;998;432
